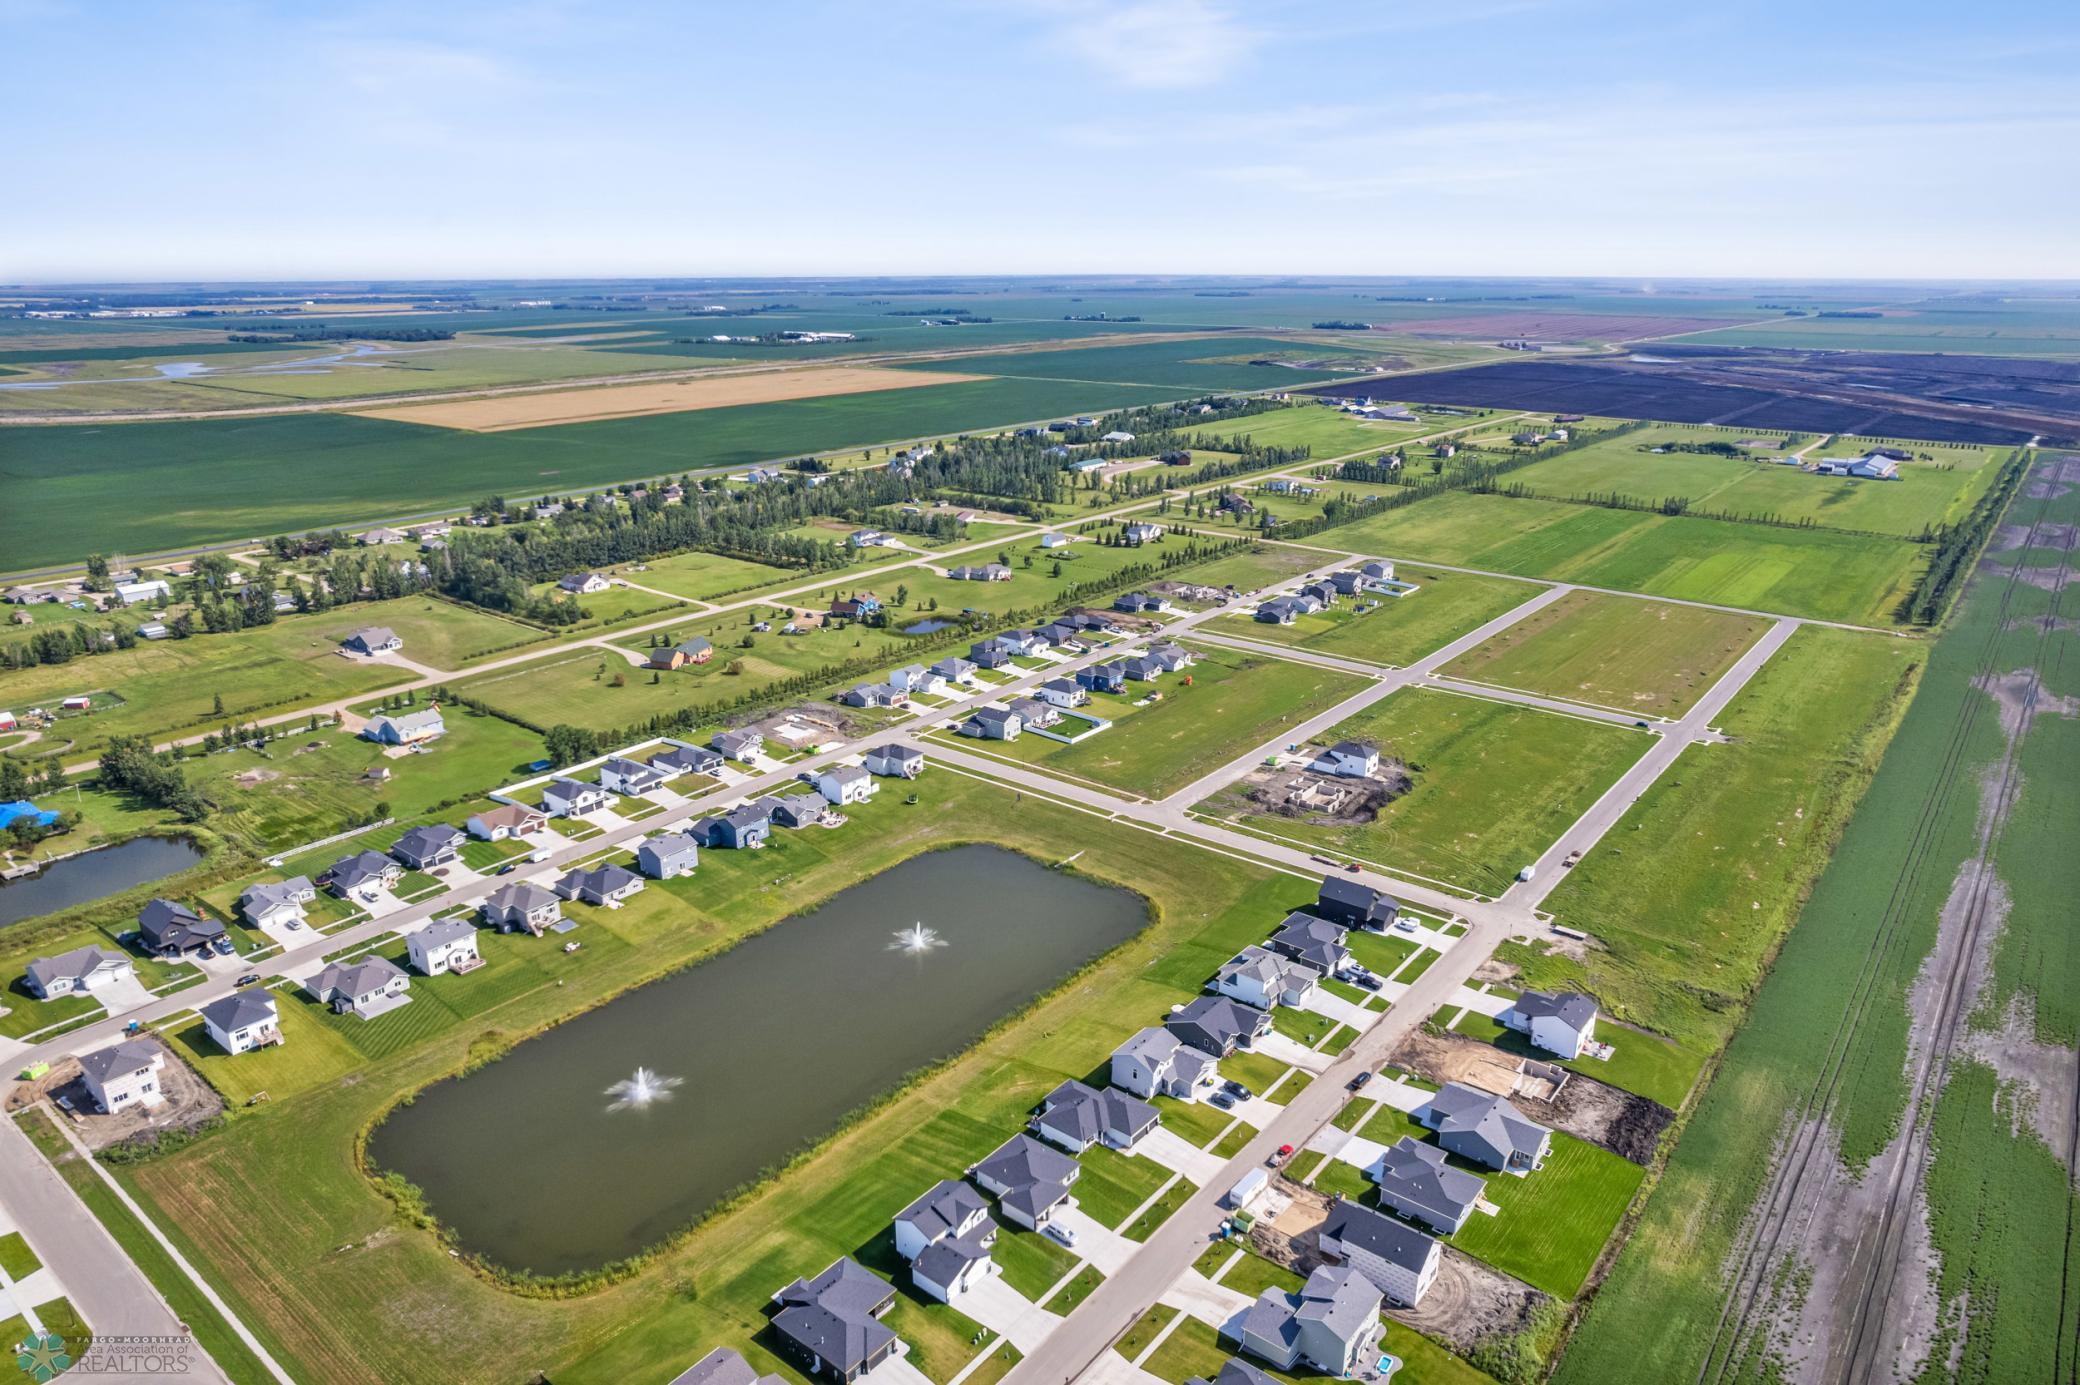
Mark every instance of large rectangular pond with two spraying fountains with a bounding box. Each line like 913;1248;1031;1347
368;846;1148;1275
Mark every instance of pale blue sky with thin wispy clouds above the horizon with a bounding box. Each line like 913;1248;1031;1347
0;0;2080;281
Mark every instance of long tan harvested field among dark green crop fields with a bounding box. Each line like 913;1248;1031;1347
358;366;980;433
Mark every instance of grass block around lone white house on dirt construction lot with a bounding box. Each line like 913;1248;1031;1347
1196;688;1647;894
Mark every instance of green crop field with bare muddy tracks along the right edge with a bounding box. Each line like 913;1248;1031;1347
1558;461;2080;1385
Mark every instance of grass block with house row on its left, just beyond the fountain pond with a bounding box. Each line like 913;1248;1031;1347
948;647;1364;799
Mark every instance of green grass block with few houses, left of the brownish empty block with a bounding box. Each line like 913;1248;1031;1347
1206;555;1539;665
